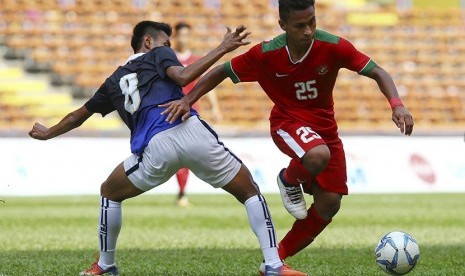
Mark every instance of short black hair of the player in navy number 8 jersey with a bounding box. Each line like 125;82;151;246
131;21;173;53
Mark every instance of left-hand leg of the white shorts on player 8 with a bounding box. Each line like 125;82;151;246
124;135;182;191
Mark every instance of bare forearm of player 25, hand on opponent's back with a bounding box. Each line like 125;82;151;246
160;65;226;123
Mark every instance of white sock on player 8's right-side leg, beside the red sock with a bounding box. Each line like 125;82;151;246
244;195;283;268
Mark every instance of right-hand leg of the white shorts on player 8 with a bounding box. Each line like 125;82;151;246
183;118;242;188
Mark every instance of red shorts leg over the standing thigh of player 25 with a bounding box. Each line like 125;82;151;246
314;142;348;195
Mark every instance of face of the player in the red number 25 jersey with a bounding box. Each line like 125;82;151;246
279;7;316;47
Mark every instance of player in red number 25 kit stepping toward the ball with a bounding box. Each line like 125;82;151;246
165;0;413;273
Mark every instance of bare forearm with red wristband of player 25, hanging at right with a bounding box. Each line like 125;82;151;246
370;66;414;135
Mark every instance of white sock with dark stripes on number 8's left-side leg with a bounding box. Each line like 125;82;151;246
98;197;122;269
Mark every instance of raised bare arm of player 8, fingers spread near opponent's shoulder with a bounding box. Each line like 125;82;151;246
166;25;250;86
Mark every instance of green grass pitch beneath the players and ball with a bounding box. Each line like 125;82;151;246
0;194;465;276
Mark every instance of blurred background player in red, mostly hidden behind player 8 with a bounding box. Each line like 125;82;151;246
173;22;221;208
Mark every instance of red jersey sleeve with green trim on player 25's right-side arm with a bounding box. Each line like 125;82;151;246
339;38;376;76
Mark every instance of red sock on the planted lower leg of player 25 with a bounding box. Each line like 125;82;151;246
278;204;331;260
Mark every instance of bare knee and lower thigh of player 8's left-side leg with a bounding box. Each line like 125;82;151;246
100;163;144;202
